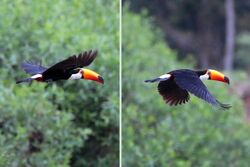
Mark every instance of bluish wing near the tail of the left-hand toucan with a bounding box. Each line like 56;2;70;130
21;61;47;75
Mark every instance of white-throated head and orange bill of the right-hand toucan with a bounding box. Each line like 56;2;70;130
200;69;230;84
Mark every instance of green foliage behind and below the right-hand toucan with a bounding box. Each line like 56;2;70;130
122;8;250;167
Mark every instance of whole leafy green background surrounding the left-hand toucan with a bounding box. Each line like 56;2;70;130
0;0;119;167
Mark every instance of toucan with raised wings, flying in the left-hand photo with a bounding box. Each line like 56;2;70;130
16;50;104;84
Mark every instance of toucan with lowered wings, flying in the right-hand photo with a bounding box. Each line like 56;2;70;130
145;69;231;109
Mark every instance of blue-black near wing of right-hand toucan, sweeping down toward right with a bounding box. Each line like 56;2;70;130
173;70;231;109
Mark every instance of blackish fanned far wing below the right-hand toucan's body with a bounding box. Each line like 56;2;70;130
158;79;190;105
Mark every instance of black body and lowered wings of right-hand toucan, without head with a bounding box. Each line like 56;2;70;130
148;69;230;109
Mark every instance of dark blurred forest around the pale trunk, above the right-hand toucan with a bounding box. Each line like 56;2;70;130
123;0;250;69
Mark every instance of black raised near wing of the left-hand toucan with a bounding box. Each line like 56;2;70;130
43;50;97;80
